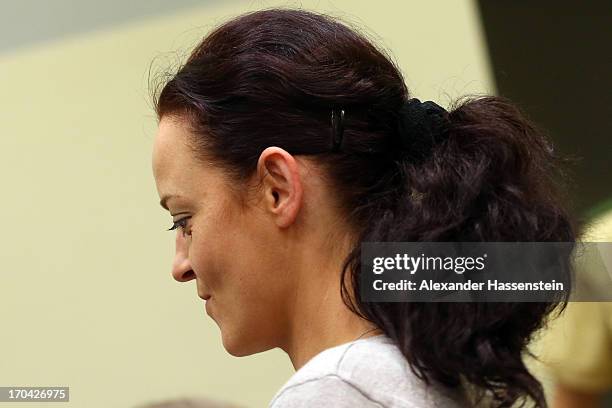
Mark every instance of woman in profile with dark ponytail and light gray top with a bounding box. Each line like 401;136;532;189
153;9;574;408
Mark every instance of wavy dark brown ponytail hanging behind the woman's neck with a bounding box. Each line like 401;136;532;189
342;96;574;407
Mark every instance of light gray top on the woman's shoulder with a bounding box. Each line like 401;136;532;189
269;335;467;408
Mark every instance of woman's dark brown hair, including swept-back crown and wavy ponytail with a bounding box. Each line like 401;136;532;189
156;9;574;407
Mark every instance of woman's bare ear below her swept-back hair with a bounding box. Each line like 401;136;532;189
257;146;304;228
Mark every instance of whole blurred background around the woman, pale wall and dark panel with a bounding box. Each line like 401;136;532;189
0;0;612;408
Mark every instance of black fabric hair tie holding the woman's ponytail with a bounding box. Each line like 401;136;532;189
399;98;450;162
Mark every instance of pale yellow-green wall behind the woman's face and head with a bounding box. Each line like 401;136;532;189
0;0;493;408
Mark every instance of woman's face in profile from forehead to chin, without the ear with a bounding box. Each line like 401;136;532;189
153;117;291;356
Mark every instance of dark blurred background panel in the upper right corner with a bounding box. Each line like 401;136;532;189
478;0;612;214
